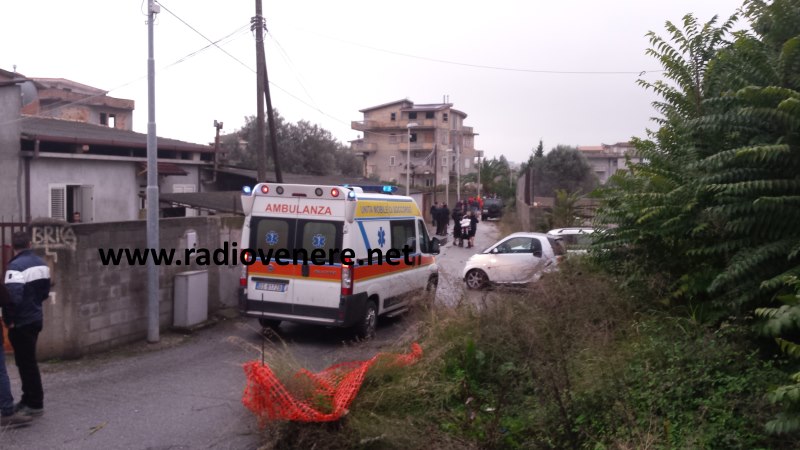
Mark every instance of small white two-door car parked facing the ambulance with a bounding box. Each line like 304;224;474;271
462;233;564;289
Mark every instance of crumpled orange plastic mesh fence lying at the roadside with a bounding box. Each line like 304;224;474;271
242;343;422;426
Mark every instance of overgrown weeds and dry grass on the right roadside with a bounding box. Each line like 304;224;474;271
256;258;793;449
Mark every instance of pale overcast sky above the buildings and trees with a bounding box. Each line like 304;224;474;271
0;0;741;162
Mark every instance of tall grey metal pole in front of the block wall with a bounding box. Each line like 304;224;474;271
145;0;161;343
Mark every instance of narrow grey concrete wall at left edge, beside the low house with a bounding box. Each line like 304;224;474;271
0;86;25;220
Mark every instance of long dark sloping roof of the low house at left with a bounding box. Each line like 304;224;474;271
20;116;214;153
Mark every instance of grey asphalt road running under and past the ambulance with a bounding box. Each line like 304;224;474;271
0;223;498;450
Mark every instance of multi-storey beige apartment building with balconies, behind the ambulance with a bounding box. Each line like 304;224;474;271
350;99;481;188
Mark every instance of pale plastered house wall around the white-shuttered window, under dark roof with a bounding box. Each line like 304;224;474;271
31;158;139;222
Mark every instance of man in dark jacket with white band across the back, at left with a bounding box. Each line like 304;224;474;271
3;231;50;417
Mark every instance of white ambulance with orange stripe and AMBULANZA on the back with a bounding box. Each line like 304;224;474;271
239;183;440;338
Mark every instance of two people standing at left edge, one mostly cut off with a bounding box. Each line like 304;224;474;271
0;232;50;430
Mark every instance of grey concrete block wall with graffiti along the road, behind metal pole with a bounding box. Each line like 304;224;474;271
32;216;242;359
